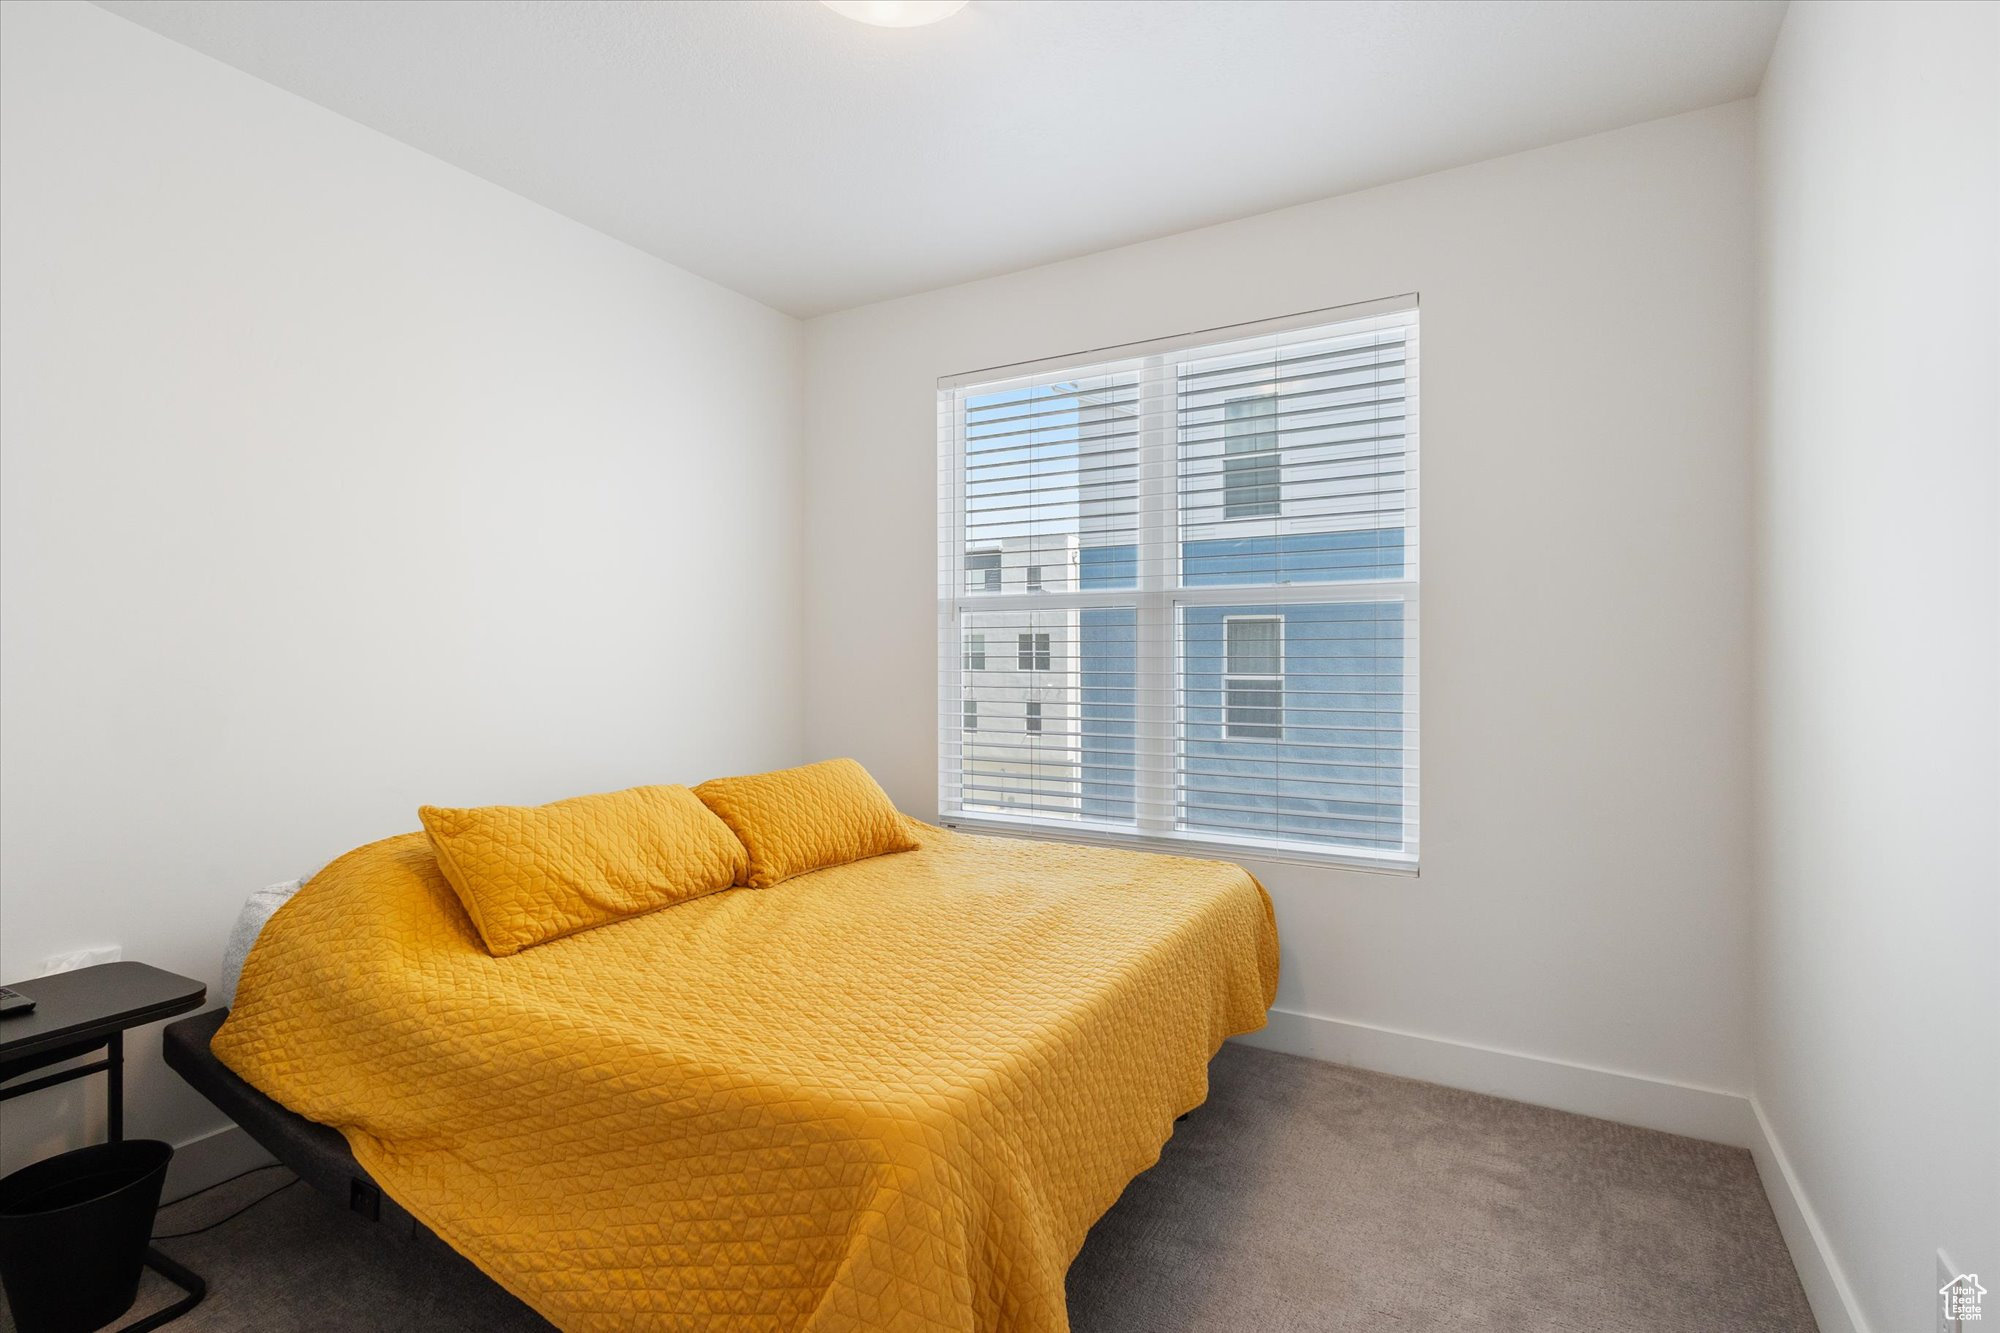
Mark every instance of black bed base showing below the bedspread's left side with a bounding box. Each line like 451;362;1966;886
160;1009;436;1249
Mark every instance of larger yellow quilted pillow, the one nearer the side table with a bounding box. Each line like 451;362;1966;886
418;787;746;959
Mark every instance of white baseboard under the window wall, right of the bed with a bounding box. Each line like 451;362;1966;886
1236;1009;1760;1149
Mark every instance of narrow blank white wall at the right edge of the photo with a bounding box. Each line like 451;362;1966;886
1756;0;2000;1333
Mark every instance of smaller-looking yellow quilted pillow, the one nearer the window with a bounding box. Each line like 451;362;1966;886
694;759;918;889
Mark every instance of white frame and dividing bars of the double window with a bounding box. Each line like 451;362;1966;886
938;294;1422;877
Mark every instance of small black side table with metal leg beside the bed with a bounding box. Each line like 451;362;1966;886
0;963;208;1333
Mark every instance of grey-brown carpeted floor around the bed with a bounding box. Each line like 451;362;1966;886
31;1045;1814;1333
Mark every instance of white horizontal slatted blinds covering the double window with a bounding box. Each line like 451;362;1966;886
938;298;1418;869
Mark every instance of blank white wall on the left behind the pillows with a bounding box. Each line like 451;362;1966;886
0;0;802;1163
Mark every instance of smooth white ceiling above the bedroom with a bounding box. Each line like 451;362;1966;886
98;0;1784;316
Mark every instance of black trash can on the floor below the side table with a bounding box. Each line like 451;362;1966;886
0;1139;174;1333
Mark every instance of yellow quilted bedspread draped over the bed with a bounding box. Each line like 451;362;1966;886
214;821;1278;1333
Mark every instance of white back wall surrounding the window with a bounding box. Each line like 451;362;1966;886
806;104;1754;1105
